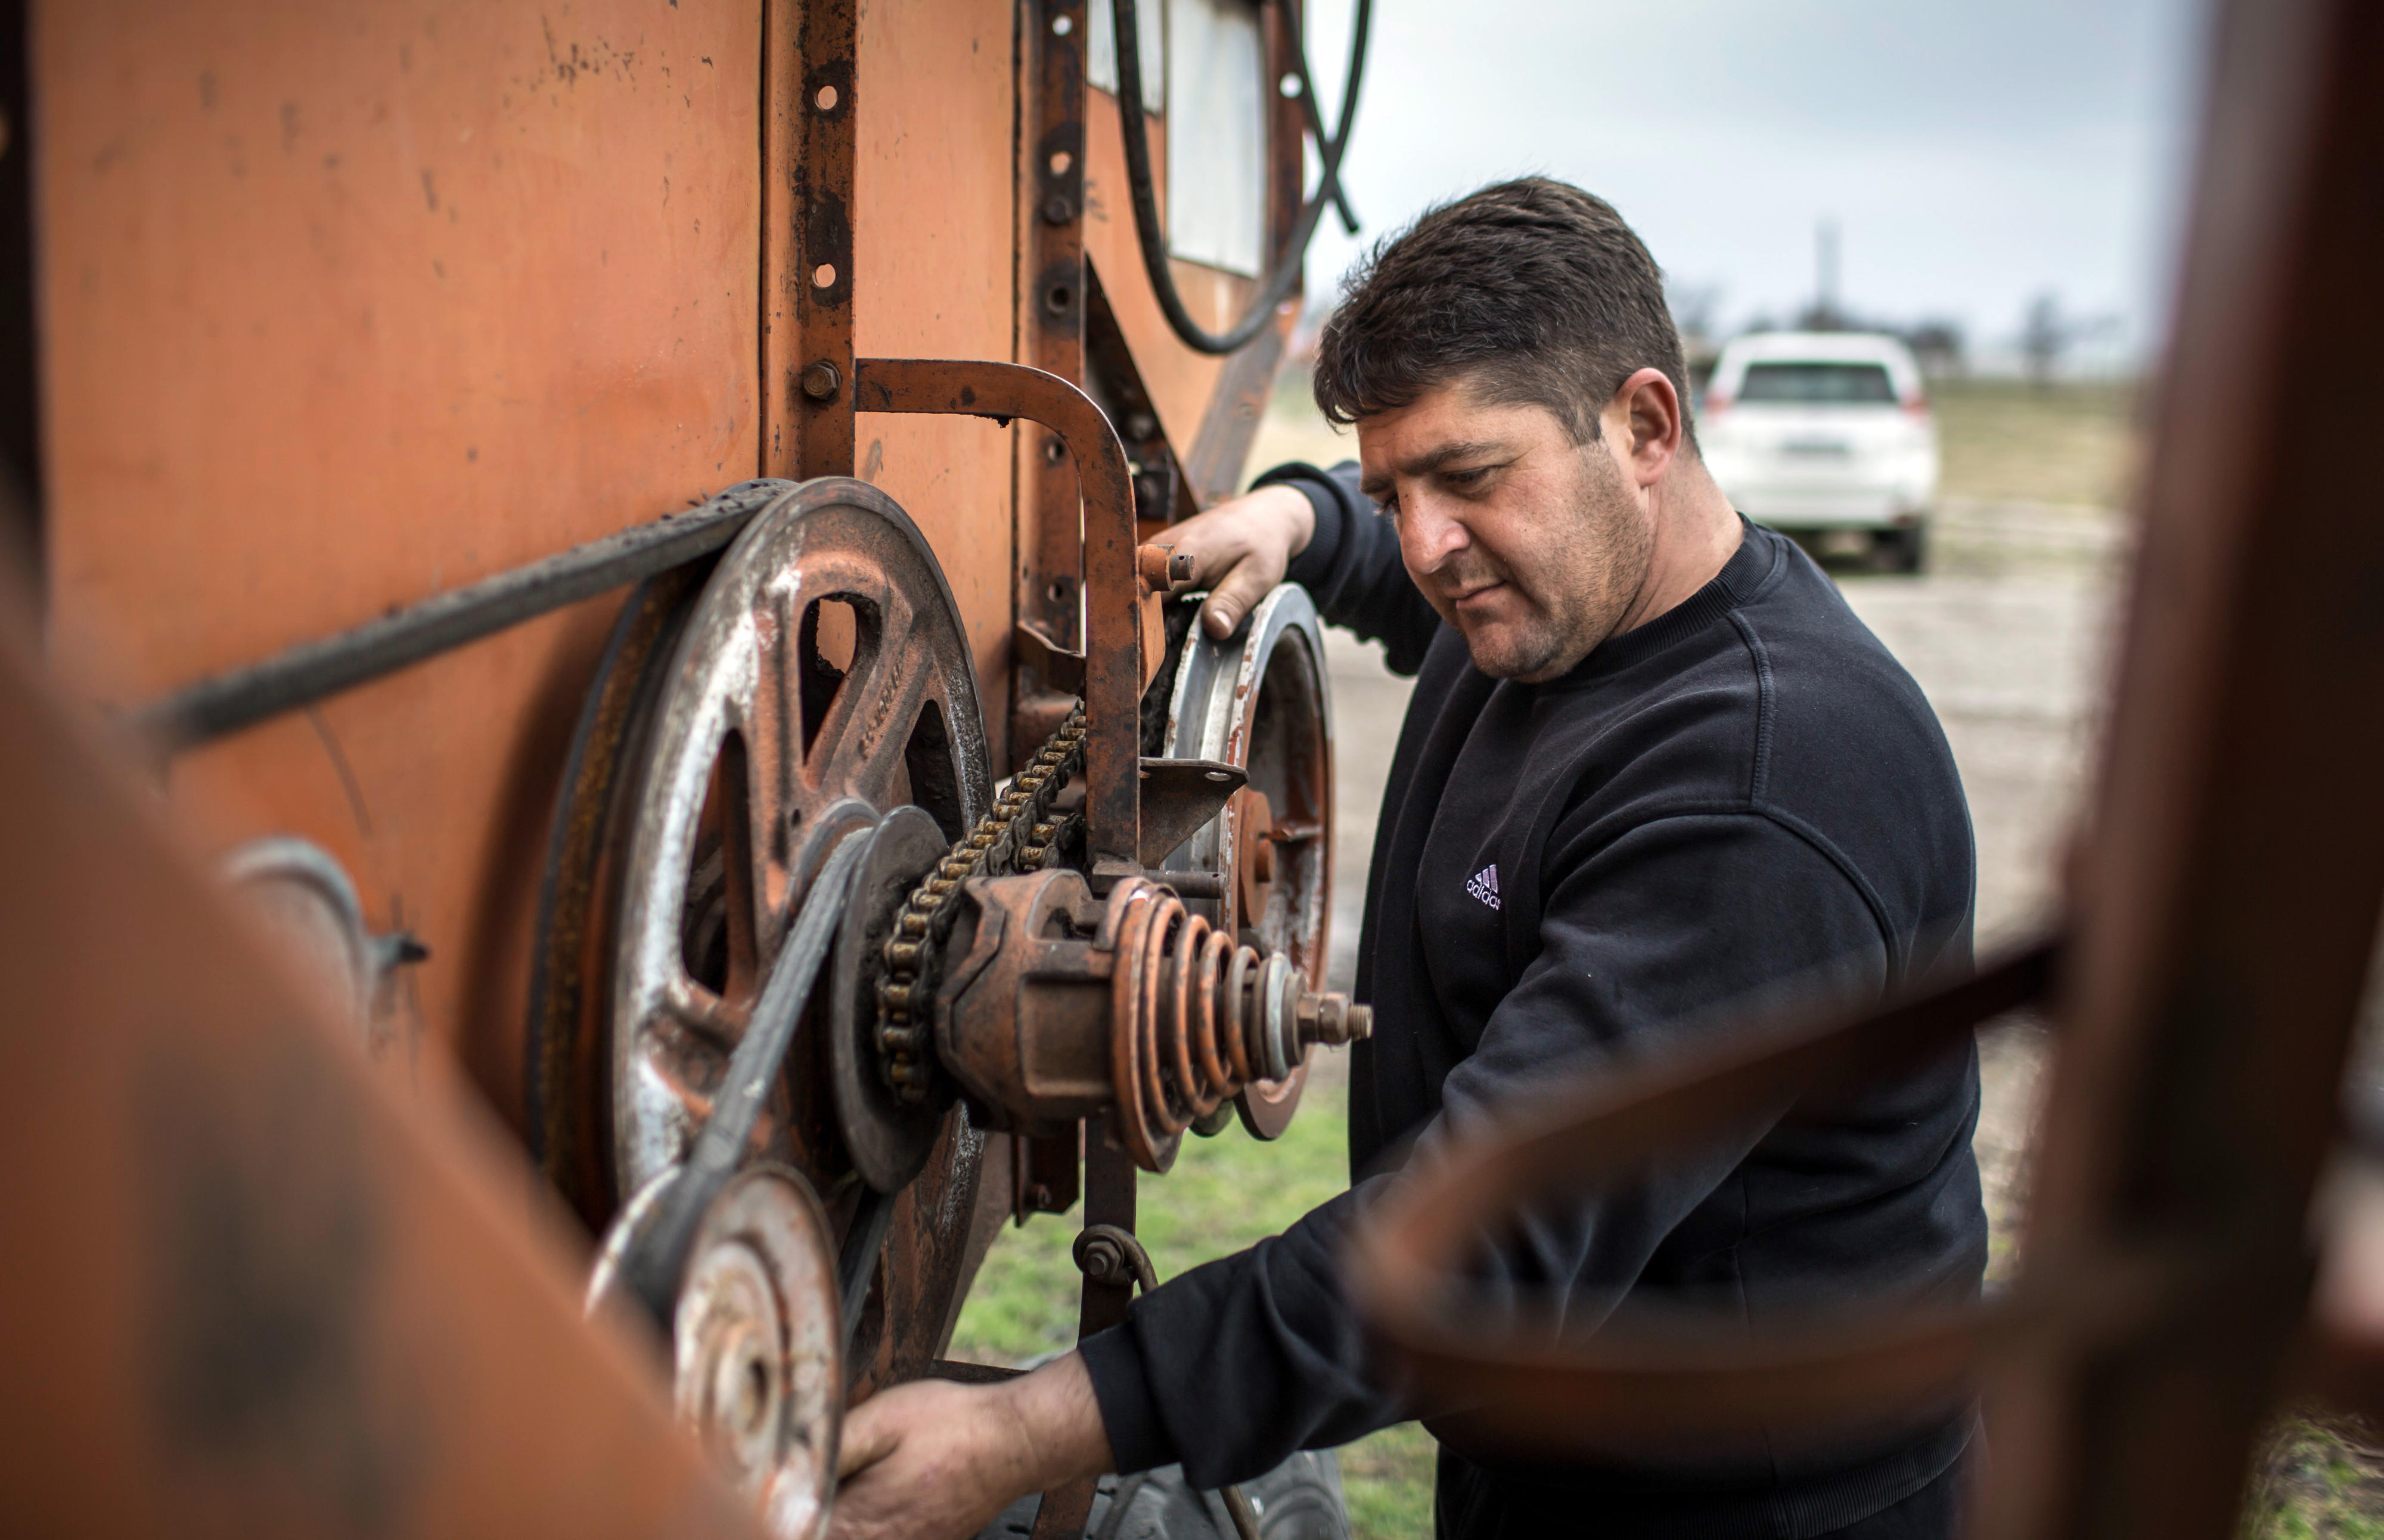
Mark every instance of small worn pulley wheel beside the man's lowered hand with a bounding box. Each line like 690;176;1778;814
589;1163;844;1540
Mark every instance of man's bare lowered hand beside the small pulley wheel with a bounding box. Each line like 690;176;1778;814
827;1354;1116;1540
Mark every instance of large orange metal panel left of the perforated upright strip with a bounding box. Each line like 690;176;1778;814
33;0;760;1135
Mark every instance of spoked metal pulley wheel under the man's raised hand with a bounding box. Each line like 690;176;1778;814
1159;584;1333;1140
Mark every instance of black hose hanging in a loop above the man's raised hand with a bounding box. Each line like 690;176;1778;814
1111;0;1373;353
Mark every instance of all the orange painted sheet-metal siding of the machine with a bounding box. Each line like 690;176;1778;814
33;0;1287;1182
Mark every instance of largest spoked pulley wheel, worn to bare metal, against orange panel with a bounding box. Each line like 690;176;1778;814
529;479;989;1404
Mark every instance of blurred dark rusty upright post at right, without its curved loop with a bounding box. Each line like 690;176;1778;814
1988;0;2384;1540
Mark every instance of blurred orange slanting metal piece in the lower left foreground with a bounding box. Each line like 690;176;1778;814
0;625;758;1538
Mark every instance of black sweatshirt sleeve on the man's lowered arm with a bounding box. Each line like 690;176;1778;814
1082;813;1888;1488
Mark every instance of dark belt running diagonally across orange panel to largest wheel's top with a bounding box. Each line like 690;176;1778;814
131;482;787;753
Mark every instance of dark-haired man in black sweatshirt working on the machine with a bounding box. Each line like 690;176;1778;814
837;179;1986;1540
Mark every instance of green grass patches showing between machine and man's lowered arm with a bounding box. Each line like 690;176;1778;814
951;1075;1438;1540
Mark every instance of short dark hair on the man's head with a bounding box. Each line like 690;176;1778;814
1316;176;1695;446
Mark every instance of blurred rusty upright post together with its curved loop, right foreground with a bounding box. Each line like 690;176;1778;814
1354;0;2384;1540
